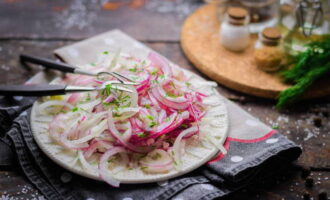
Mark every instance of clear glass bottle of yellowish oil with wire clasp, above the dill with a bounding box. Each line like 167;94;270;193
280;0;330;54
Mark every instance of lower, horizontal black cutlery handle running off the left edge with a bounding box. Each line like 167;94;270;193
0;85;66;96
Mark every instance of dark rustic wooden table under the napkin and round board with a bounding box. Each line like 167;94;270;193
0;0;330;200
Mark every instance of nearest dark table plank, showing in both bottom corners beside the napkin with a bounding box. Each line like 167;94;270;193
0;171;330;200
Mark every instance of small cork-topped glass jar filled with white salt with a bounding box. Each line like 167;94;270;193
220;7;250;51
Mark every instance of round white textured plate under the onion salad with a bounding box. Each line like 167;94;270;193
31;65;228;184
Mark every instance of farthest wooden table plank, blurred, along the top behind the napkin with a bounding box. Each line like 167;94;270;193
0;0;202;41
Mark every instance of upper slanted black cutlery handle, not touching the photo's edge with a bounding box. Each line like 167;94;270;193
20;54;76;73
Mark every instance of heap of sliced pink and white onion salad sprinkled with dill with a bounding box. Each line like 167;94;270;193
37;52;220;187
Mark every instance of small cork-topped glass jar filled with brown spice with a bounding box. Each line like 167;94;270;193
254;27;285;72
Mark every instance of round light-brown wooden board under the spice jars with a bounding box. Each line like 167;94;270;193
181;4;330;98
